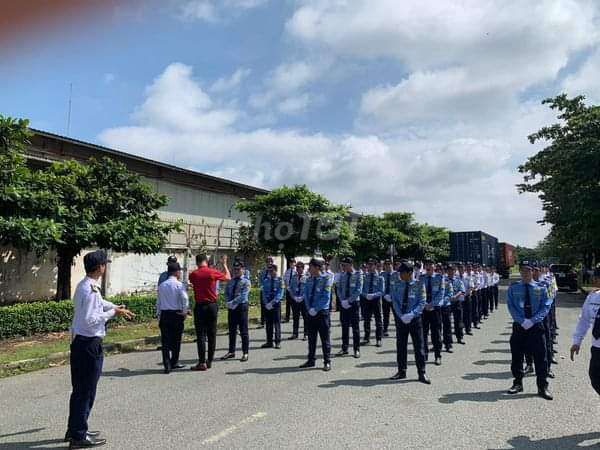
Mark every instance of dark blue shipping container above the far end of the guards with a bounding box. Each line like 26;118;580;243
450;231;498;266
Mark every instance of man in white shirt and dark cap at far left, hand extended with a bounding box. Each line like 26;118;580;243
65;250;135;448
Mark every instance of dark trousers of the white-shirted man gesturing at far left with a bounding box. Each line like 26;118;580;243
67;336;104;440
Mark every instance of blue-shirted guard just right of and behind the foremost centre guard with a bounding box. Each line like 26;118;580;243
336;256;363;358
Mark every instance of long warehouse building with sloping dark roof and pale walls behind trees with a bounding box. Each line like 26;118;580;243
0;130;268;304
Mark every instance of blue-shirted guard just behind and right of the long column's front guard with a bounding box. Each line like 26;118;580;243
419;259;446;366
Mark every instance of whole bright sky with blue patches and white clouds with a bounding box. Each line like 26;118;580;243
0;0;600;245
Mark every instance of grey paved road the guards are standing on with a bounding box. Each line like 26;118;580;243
0;288;600;449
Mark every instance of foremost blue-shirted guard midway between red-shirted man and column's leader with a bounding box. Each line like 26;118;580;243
300;258;333;372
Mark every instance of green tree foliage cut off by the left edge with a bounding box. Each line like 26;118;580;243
0;115;60;254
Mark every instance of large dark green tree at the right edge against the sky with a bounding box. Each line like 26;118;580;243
518;94;600;265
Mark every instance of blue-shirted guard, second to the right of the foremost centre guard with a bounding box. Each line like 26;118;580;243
362;258;385;347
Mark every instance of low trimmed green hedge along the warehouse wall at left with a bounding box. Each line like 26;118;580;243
0;288;259;339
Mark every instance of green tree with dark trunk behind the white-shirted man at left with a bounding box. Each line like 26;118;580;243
39;158;179;299
